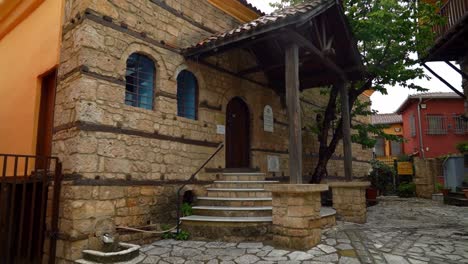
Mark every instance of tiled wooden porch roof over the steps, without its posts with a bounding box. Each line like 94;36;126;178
184;0;363;93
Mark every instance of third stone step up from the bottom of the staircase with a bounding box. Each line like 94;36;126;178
197;196;272;207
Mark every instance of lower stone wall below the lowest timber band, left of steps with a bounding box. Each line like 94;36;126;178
52;183;203;263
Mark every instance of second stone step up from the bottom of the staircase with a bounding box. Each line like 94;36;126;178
193;206;273;217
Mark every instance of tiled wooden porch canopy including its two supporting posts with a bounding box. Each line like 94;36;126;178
184;0;364;183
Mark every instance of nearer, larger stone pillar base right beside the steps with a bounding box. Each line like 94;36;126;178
266;184;328;250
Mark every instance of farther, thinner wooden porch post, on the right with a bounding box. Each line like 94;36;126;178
336;80;353;181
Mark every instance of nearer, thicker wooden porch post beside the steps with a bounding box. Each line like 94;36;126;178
285;44;302;184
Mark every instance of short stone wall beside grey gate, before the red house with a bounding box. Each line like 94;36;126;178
413;158;442;199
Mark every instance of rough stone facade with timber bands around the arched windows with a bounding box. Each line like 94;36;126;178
53;0;372;262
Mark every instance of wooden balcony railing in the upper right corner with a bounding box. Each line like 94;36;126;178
434;0;468;38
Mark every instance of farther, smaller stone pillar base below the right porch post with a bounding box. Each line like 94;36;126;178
328;182;370;224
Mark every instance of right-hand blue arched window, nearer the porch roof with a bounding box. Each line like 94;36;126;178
177;70;198;120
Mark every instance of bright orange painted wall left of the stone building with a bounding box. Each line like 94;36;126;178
0;0;63;154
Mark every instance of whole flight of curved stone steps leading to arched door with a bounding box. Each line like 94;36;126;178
181;172;278;241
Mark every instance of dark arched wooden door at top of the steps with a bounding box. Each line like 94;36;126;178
226;97;250;168
